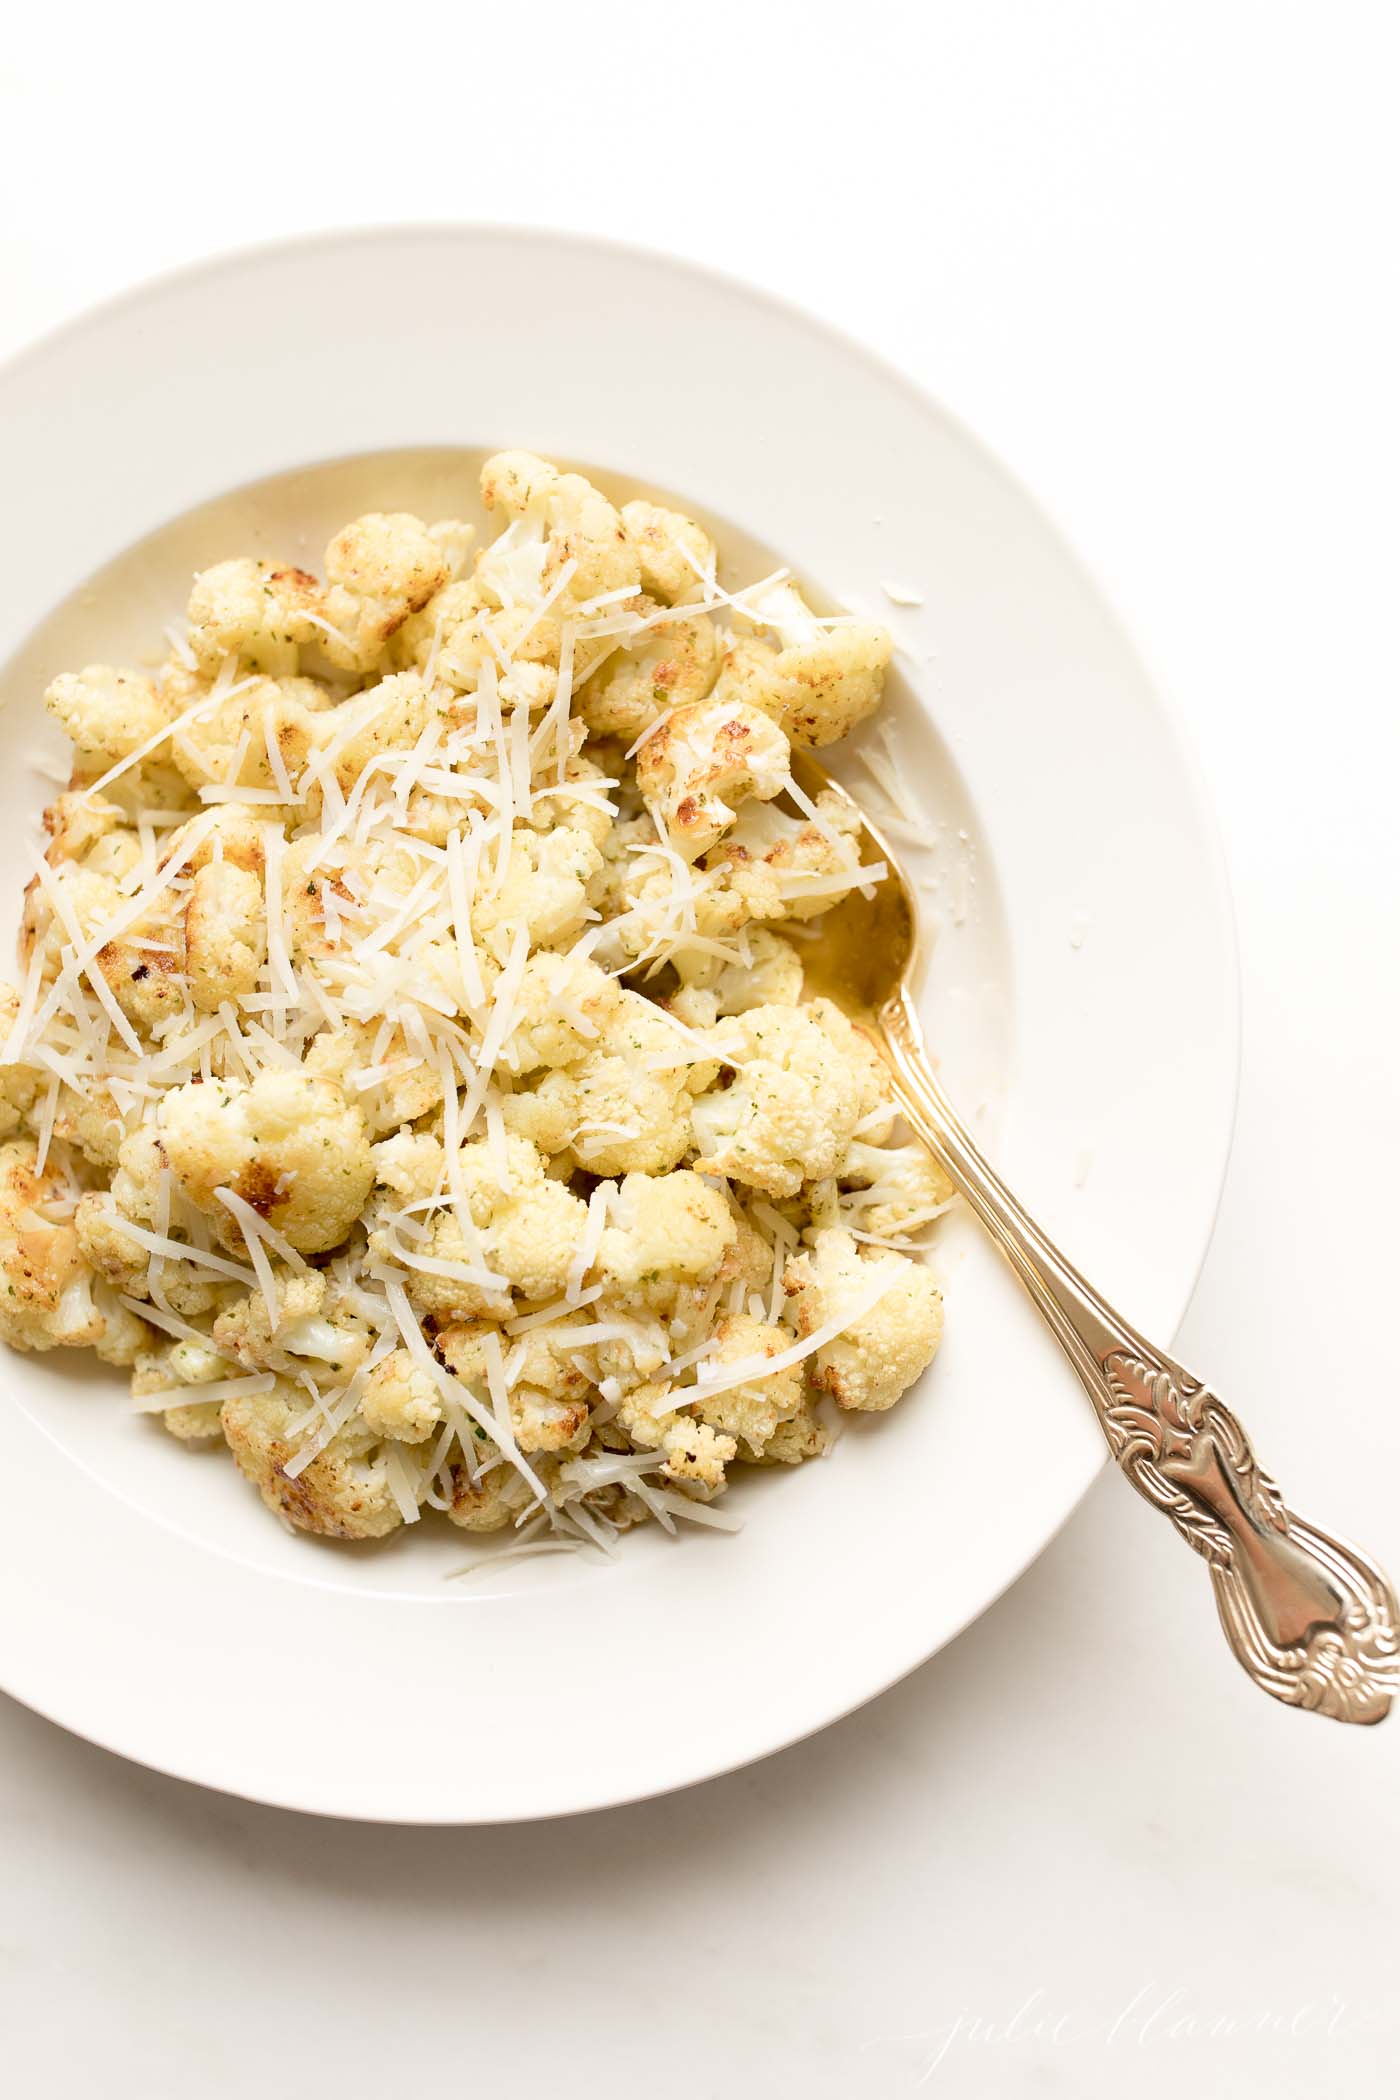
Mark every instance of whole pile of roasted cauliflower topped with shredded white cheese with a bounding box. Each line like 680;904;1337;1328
0;452;951;1552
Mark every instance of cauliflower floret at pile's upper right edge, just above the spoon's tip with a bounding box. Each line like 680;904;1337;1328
716;584;894;750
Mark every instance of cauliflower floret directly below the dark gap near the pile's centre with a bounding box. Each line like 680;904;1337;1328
506;991;693;1174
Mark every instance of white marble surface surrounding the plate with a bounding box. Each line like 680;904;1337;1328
0;0;1400;2100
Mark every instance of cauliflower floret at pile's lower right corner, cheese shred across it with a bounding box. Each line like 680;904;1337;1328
783;1226;942;1413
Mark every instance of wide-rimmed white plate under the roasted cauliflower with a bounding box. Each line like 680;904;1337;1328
0;227;1236;1823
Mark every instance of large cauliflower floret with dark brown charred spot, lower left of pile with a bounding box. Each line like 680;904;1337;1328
155;1069;374;1254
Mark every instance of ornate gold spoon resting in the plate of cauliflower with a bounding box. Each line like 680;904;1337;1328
793;752;1400;1722
